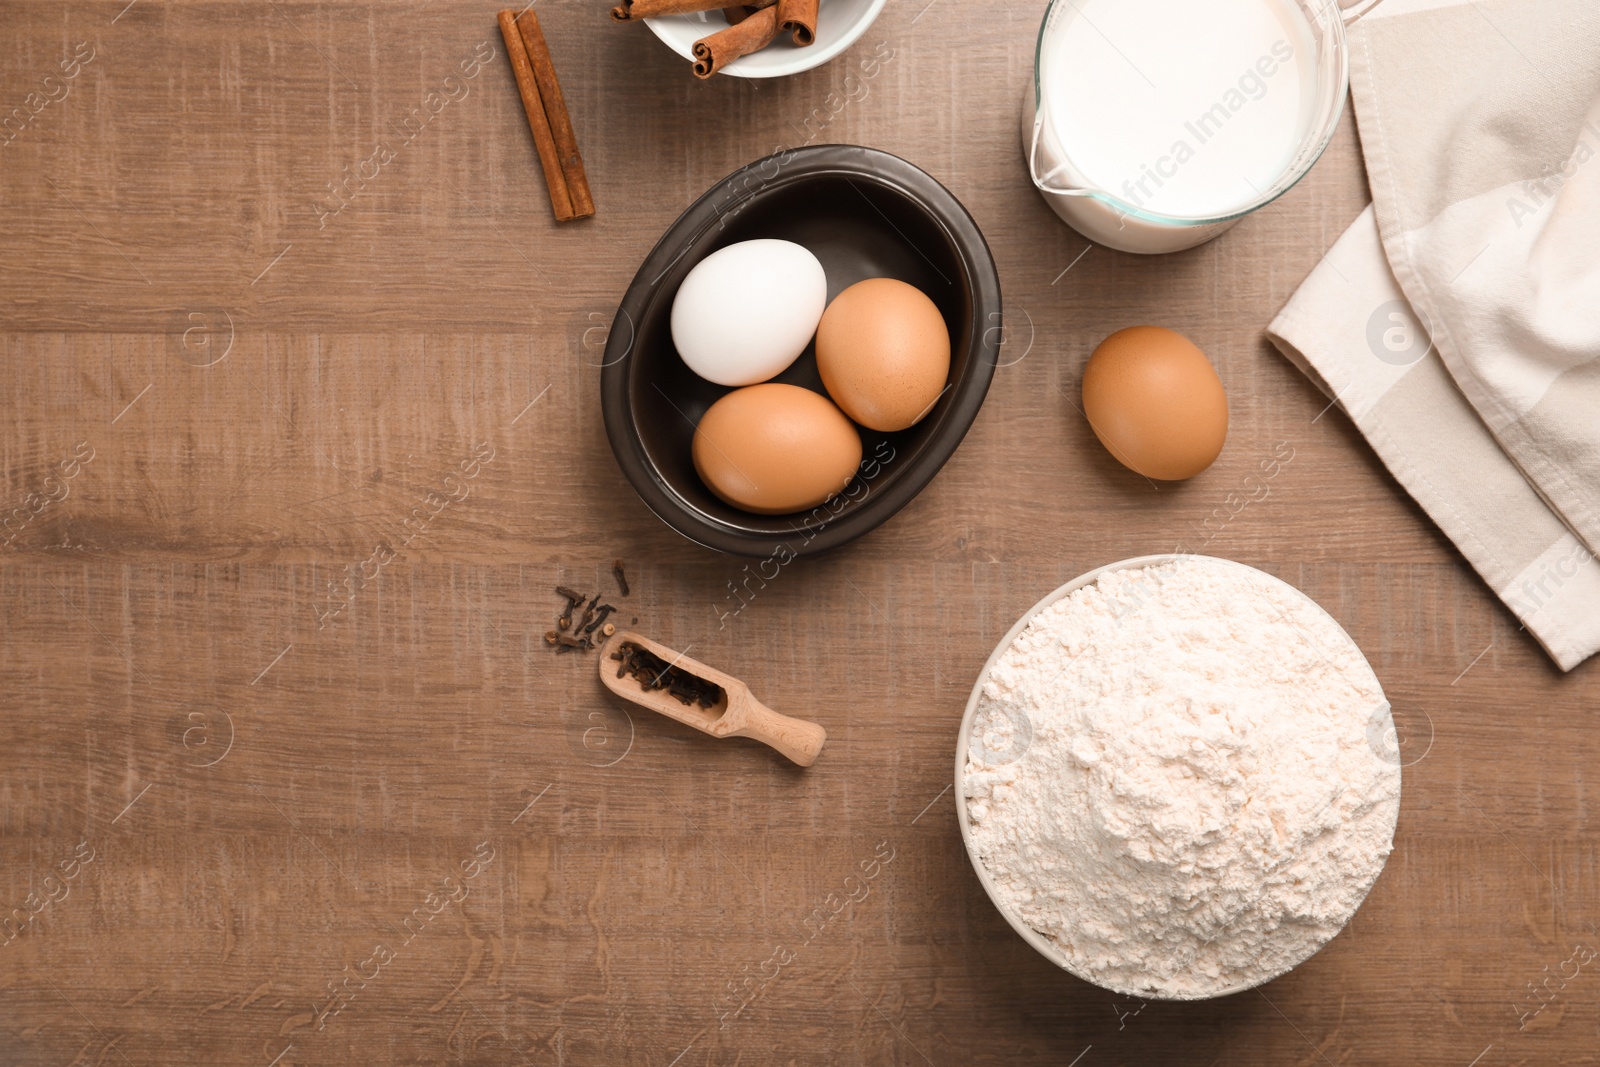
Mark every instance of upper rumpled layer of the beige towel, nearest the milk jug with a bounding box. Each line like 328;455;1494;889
1349;0;1600;563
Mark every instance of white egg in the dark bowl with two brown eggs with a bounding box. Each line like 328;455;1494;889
672;240;827;386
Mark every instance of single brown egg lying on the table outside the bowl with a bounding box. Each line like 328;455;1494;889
1083;326;1227;482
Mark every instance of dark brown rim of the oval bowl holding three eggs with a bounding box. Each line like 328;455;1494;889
600;144;1003;557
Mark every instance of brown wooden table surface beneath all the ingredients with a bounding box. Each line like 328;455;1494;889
0;0;1600;1067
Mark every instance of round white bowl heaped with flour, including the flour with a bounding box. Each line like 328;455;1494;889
955;555;1400;1000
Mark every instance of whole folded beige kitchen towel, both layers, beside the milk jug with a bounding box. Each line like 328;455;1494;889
1267;0;1600;670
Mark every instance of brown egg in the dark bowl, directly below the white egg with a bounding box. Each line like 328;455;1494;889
694;382;861;515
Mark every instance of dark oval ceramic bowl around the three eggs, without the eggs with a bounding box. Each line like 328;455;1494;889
600;144;1002;557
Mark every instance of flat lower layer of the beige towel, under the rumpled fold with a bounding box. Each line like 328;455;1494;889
1267;208;1600;670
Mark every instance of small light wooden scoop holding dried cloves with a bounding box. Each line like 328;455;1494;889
600;630;827;766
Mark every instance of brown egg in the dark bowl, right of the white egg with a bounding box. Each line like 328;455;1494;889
816;278;950;430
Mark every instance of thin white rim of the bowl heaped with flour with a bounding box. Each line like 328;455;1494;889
955;553;1398;1000
